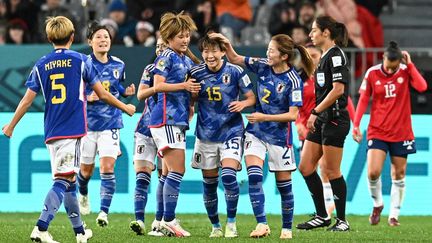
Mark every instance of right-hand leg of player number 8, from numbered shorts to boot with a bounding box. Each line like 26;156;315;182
96;129;120;227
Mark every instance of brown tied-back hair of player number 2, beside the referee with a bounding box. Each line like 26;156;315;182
271;34;314;76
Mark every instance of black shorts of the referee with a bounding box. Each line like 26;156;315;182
306;110;350;148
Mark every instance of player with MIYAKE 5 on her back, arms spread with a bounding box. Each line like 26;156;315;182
2;16;135;243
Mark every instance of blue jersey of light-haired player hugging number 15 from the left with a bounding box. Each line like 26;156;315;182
149;48;194;129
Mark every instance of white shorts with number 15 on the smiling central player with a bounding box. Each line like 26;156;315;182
191;137;243;170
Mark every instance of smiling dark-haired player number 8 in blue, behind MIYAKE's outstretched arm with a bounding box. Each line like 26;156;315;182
78;22;135;227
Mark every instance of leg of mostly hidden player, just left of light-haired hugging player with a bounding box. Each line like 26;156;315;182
129;133;157;235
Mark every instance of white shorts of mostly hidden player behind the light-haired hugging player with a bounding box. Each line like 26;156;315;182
133;132;162;170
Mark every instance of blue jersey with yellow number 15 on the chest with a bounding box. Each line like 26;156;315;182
191;62;252;142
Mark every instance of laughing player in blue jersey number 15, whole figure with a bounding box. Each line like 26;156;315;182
191;35;256;238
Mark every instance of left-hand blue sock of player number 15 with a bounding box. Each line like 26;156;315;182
203;176;220;228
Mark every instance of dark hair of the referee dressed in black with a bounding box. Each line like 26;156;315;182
315;16;348;47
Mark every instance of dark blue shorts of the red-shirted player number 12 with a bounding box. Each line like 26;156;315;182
368;139;417;158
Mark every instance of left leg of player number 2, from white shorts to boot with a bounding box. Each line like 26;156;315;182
244;133;270;238
